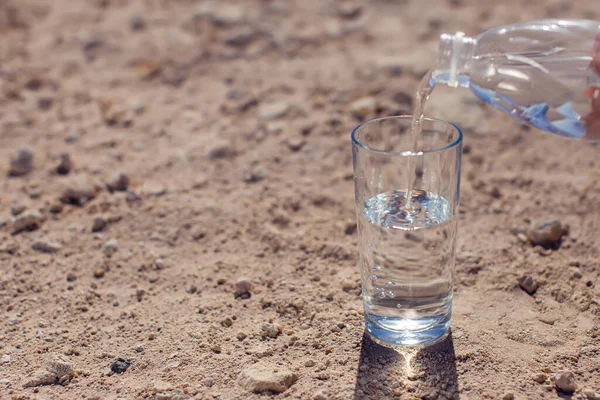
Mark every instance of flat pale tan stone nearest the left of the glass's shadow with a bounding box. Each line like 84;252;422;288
238;363;298;393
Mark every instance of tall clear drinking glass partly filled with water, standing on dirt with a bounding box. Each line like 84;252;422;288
352;115;462;346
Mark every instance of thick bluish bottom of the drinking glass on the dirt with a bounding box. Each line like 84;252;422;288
365;316;450;347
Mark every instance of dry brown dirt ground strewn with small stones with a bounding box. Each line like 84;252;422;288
0;0;600;400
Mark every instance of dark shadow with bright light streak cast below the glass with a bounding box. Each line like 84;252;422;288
354;332;460;400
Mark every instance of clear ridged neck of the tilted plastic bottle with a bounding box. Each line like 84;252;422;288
434;32;477;87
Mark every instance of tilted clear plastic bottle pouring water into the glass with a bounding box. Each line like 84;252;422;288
431;20;600;141
